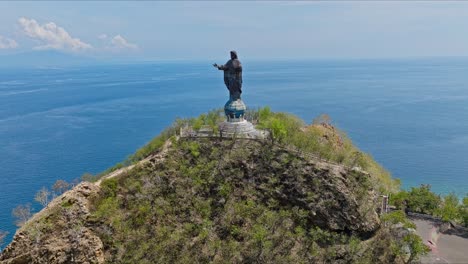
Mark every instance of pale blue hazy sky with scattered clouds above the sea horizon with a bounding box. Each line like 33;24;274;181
0;1;468;60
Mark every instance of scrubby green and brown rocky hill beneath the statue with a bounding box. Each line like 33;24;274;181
0;108;424;263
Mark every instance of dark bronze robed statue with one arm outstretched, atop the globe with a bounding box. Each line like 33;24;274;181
213;51;242;101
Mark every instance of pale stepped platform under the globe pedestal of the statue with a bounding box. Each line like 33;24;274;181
219;119;268;139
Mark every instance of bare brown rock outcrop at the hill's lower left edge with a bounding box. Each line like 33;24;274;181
0;182;104;264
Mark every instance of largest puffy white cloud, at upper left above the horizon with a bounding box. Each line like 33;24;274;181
18;17;92;51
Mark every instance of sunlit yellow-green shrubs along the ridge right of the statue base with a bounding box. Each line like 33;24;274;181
251;107;400;193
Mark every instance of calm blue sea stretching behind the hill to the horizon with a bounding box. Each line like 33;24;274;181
0;59;468;245
